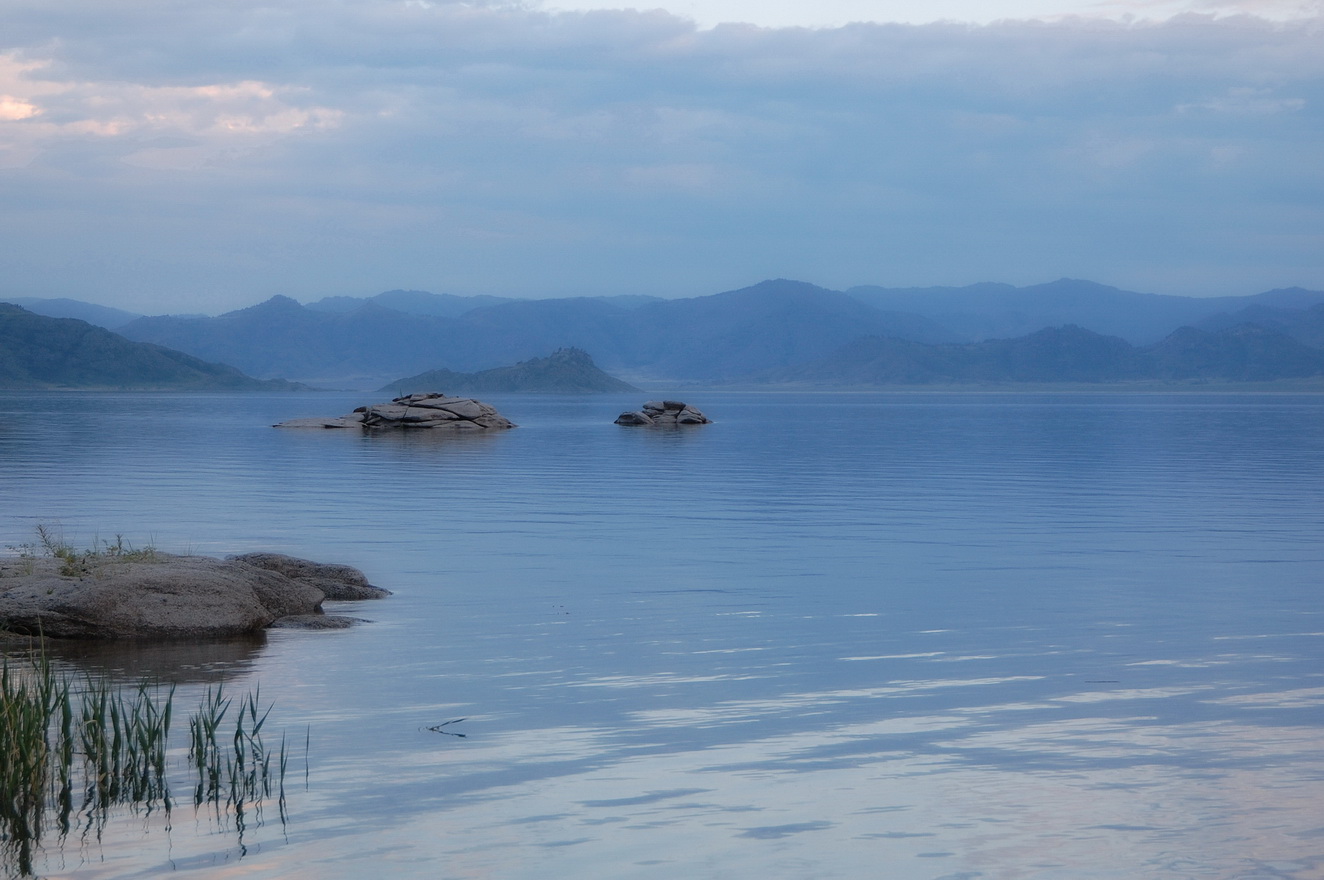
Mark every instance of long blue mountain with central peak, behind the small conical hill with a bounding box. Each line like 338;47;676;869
105;281;951;388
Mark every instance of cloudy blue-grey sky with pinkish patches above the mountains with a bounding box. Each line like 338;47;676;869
0;0;1324;314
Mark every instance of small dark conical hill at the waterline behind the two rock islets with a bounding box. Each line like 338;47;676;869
379;348;639;394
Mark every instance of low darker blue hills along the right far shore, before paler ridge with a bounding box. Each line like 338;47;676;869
755;324;1324;386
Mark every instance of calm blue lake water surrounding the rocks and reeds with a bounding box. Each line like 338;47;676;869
0;393;1324;880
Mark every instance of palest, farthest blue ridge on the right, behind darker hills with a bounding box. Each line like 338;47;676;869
847;278;1324;344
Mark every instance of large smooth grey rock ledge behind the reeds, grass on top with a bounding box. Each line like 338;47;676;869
0;553;391;640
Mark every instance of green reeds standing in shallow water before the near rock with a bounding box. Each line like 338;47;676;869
0;655;289;876
